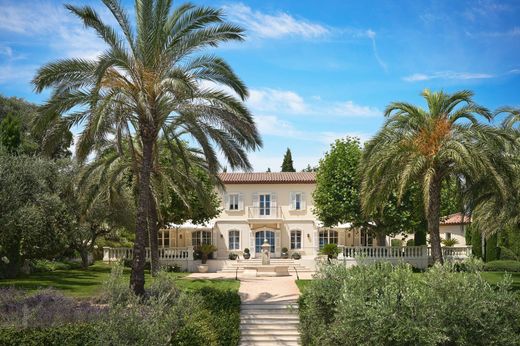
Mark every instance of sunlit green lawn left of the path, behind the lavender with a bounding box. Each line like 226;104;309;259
0;262;240;298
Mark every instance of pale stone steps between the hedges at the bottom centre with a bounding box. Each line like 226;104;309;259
240;302;300;346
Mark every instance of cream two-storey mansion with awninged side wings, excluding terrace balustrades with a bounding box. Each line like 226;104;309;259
159;172;373;259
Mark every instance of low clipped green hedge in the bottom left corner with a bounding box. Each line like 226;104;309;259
0;323;98;346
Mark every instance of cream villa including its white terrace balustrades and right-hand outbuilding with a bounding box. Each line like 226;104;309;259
103;172;471;271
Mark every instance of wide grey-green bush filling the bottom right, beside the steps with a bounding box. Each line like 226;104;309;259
299;264;520;346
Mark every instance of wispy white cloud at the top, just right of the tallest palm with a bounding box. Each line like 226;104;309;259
224;3;330;39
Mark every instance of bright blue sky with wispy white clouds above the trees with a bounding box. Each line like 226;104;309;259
0;0;520;171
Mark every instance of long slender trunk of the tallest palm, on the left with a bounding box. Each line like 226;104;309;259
130;136;153;295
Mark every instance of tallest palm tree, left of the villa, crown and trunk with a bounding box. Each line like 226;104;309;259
33;0;261;295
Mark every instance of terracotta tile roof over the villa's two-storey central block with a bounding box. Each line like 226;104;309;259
219;172;316;184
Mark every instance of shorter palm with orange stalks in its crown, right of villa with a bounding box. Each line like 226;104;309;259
362;89;508;263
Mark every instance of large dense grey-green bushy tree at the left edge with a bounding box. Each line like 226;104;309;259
0;152;73;277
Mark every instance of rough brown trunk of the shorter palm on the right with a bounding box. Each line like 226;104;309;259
426;177;443;264
